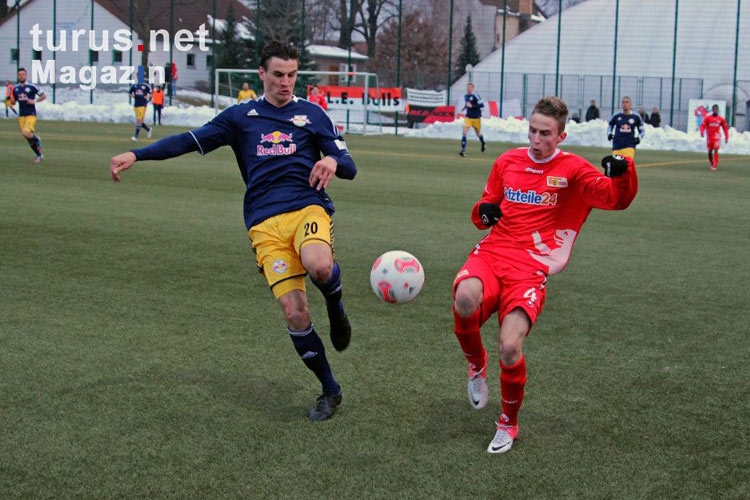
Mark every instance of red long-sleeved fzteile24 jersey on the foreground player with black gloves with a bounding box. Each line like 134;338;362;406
471;147;638;274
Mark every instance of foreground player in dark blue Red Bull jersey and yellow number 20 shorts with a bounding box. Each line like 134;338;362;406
110;41;357;421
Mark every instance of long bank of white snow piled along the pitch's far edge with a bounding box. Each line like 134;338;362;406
23;88;750;154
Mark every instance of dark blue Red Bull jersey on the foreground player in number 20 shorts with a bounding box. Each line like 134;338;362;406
191;96;357;229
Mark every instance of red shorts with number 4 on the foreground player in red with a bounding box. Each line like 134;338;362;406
453;252;547;326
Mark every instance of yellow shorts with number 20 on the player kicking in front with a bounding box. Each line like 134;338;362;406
248;205;333;299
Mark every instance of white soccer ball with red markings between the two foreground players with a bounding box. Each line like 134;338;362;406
370;250;424;304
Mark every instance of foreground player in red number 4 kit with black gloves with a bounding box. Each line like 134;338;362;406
453;97;638;453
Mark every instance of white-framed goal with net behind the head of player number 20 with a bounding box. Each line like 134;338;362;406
213;68;384;134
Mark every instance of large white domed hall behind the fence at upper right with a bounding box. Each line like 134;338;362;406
451;0;750;129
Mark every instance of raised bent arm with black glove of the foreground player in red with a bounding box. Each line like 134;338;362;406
576;155;638;210
